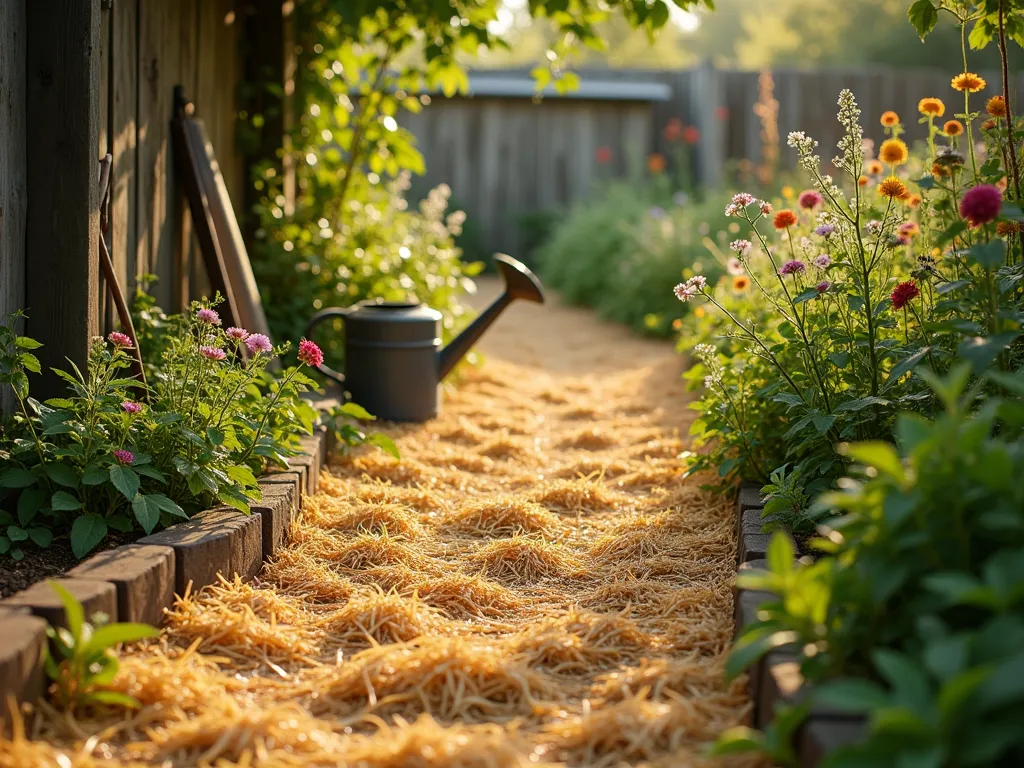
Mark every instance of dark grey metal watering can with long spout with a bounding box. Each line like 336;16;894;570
306;254;544;421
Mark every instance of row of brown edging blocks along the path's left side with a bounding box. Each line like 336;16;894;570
0;427;332;732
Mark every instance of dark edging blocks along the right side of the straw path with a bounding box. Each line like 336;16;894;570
733;485;865;768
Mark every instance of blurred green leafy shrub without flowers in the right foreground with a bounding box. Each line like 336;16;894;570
724;364;1024;767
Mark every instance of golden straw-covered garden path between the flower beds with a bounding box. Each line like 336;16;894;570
6;286;756;768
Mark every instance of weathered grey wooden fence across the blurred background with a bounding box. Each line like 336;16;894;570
402;66;1024;255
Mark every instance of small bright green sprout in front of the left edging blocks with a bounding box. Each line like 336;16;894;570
43;582;160;714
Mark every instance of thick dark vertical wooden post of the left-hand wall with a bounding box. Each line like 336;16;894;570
26;0;101;399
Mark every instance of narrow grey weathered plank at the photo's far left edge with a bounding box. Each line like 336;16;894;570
0;2;28;413
